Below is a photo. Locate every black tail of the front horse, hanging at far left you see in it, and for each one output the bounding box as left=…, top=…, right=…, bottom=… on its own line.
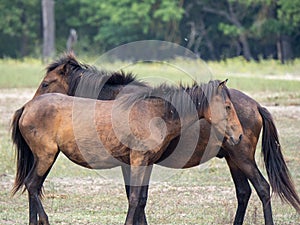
left=11, top=106, right=34, bottom=195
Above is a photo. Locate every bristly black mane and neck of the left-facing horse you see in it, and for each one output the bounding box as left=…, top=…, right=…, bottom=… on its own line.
left=47, top=54, right=146, bottom=99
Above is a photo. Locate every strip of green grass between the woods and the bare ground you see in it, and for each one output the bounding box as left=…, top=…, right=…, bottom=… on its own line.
left=0, top=58, right=300, bottom=92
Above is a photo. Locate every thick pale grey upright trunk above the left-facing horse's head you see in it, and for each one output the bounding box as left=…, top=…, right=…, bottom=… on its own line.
left=42, top=0, right=55, bottom=62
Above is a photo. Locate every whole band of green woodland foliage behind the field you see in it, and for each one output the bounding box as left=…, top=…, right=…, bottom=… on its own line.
left=0, top=0, right=300, bottom=59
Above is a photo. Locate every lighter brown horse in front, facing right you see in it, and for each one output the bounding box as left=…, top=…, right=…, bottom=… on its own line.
left=14, top=77, right=242, bottom=224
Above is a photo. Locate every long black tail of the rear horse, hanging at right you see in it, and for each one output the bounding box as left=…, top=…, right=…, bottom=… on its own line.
left=258, top=106, right=300, bottom=213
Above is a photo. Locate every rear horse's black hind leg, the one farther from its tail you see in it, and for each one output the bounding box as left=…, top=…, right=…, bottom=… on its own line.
left=226, top=157, right=251, bottom=225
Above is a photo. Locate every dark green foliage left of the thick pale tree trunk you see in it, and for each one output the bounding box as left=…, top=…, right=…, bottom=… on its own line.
left=0, top=0, right=40, bottom=57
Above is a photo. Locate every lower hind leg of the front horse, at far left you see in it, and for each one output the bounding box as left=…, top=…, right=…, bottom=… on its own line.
left=24, top=146, right=58, bottom=225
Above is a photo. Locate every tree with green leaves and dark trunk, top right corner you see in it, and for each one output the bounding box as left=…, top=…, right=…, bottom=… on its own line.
left=252, top=0, right=300, bottom=63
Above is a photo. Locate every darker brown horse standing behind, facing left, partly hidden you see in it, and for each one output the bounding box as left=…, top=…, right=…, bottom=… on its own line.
left=12, top=55, right=300, bottom=224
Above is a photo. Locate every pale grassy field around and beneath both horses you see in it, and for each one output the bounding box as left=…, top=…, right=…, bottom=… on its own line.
left=0, top=59, right=300, bottom=225
